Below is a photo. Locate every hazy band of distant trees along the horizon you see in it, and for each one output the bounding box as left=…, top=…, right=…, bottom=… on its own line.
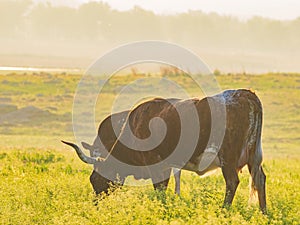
left=0, top=0, right=300, bottom=57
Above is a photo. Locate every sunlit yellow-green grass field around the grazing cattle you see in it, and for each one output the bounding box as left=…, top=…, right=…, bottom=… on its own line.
left=0, top=73, right=300, bottom=225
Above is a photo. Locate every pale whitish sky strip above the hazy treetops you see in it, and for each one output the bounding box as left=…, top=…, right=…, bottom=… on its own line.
left=43, top=0, right=300, bottom=19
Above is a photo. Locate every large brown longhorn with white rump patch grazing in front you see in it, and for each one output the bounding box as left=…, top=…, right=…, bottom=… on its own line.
left=64, top=89, right=266, bottom=212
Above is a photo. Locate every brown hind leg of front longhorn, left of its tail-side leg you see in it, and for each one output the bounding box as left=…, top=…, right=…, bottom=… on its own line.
left=222, top=167, right=240, bottom=207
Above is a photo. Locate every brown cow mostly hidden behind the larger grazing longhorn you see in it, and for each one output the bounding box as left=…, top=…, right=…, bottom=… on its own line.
left=81, top=108, right=181, bottom=195
